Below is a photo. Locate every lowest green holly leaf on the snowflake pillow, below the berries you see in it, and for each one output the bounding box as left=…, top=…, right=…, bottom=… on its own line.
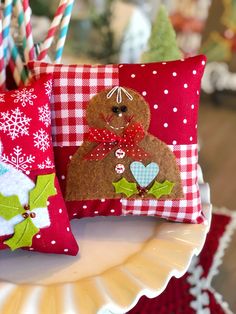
left=4, top=218, right=39, bottom=251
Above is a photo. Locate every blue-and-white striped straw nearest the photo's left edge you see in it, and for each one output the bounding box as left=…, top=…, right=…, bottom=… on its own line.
left=2, top=0, right=12, bottom=65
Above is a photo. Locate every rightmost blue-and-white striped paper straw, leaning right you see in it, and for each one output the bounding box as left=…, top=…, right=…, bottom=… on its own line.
left=55, top=0, right=74, bottom=63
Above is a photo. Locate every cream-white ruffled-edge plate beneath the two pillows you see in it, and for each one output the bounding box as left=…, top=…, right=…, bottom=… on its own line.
left=0, top=174, right=211, bottom=314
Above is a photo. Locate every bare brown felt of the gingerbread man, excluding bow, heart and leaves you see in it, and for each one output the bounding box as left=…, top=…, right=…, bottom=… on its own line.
left=66, top=89, right=183, bottom=201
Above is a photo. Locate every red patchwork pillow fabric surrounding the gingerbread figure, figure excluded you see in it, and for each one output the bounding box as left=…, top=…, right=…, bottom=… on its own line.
left=29, top=55, right=206, bottom=223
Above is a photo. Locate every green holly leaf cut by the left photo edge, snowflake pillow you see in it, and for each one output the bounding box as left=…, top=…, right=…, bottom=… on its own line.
left=0, top=194, right=24, bottom=220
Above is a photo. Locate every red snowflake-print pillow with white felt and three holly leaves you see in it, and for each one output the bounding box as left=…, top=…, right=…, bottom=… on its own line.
left=0, top=75, right=78, bottom=255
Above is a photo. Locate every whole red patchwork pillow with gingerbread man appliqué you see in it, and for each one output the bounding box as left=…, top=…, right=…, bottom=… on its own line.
left=29, top=56, right=206, bottom=223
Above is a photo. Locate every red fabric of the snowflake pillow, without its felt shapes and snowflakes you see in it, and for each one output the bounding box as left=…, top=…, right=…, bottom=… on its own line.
left=0, top=75, right=78, bottom=255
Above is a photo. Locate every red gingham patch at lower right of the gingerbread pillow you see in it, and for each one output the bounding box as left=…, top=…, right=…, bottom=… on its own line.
left=122, top=144, right=203, bottom=223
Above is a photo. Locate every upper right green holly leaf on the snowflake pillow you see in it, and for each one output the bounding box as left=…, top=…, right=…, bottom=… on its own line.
left=29, top=173, right=57, bottom=210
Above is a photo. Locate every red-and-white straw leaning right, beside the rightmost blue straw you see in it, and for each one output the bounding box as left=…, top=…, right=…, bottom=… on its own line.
left=38, top=0, right=68, bottom=60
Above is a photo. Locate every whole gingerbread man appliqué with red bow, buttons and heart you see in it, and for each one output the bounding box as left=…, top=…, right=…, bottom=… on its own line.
left=66, top=86, right=183, bottom=201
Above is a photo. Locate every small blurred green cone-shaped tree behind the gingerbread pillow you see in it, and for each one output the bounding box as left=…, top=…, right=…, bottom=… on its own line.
left=142, top=5, right=181, bottom=62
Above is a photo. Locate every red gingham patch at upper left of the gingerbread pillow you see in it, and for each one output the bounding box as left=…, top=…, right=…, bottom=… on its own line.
left=28, top=62, right=119, bottom=146
